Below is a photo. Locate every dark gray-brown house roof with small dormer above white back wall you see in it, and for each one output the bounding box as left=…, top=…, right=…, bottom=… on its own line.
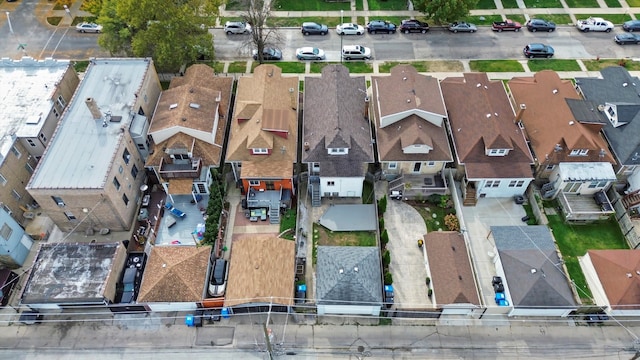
left=302, top=65, right=374, bottom=176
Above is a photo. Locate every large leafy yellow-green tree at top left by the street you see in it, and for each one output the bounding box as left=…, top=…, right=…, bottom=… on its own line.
left=97, top=0, right=221, bottom=71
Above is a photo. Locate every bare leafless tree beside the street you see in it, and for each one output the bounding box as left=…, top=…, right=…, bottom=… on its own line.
left=242, top=0, right=283, bottom=64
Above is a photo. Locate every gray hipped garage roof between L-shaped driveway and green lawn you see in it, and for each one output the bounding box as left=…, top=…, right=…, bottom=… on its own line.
left=491, top=225, right=576, bottom=307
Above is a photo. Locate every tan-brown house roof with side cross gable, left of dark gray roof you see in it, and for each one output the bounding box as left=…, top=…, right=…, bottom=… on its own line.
left=226, top=64, right=298, bottom=179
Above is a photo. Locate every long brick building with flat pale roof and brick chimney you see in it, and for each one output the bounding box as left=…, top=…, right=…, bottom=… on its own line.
left=27, top=58, right=161, bottom=234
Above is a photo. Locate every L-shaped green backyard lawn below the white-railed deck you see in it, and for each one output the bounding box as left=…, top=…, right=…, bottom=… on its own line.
left=547, top=215, right=628, bottom=301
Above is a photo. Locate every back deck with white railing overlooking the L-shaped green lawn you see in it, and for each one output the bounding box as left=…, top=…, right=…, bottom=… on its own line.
left=558, top=191, right=615, bottom=222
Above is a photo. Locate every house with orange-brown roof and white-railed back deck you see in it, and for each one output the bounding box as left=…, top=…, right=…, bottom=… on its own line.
left=509, top=70, right=616, bottom=221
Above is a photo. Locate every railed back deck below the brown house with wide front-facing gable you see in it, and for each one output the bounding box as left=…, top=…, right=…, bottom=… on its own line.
left=389, top=172, right=449, bottom=200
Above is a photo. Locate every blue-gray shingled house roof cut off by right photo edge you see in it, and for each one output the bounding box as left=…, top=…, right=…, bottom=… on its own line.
left=576, top=66, right=640, bottom=165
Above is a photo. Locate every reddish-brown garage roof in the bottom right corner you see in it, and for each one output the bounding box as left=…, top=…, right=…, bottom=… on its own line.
left=587, top=250, right=640, bottom=310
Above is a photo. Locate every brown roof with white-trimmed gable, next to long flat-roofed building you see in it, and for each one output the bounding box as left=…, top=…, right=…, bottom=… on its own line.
left=146, top=64, right=233, bottom=166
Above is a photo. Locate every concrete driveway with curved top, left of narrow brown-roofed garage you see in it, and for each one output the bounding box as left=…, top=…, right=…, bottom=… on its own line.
left=384, top=195, right=432, bottom=309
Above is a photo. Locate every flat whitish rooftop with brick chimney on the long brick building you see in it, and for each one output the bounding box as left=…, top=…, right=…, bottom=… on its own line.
left=27, top=59, right=151, bottom=189
